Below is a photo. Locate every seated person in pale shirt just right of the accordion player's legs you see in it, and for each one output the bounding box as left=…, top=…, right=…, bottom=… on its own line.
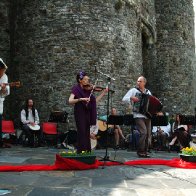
left=152, top=123, right=171, bottom=149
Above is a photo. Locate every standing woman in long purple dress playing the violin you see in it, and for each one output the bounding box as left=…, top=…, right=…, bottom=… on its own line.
left=69, top=71, right=97, bottom=153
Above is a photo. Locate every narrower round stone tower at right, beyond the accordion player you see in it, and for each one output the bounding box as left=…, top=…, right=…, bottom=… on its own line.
left=155, top=0, right=195, bottom=114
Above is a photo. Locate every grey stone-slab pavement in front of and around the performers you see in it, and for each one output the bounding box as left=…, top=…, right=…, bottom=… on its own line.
left=0, top=146, right=196, bottom=196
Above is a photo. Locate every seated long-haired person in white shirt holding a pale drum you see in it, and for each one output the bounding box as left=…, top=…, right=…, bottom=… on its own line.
left=21, top=99, right=41, bottom=146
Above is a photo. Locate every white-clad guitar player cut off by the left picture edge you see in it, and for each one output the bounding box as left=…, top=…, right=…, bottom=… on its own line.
left=0, top=58, right=10, bottom=147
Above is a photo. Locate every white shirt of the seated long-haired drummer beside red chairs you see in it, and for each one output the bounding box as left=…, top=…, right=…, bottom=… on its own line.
left=21, top=109, right=39, bottom=125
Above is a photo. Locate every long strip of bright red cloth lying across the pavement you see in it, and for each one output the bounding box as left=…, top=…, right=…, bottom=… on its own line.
left=0, top=155, right=196, bottom=172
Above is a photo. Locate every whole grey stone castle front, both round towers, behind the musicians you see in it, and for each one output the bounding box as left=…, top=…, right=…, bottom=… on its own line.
left=1, top=0, right=194, bottom=125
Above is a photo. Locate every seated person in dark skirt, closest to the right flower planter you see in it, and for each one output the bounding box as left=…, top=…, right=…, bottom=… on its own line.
left=169, top=114, right=191, bottom=149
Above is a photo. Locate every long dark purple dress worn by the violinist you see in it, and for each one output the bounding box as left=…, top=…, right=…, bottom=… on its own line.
left=71, top=84, right=97, bottom=153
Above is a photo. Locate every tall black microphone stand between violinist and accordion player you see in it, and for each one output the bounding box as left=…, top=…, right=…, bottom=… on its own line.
left=97, top=70, right=123, bottom=168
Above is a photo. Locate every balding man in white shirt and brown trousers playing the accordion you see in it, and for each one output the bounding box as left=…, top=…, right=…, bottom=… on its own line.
left=122, top=76, right=151, bottom=157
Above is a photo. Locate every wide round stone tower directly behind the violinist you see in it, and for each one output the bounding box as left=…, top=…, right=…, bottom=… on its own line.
left=9, top=0, right=154, bottom=125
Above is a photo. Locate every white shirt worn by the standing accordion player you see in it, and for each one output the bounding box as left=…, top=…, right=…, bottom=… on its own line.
left=122, top=88, right=151, bottom=118
